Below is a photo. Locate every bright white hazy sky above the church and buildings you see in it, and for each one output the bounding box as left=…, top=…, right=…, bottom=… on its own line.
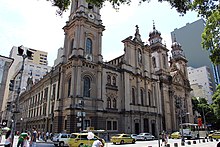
left=0, top=0, right=199, bottom=66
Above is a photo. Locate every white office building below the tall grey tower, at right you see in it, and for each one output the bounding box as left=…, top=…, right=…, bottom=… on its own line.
left=187, top=66, right=213, bottom=104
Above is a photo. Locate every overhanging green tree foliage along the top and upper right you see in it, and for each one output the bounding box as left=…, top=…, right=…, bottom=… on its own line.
left=47, top=0, right=220, bottom=64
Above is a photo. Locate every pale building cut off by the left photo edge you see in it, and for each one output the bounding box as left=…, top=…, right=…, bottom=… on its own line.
left=0, top=55, right=14, bottom=123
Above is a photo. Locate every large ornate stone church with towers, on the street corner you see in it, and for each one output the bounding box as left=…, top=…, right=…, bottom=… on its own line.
left=16, top=0, right=193, bottom=136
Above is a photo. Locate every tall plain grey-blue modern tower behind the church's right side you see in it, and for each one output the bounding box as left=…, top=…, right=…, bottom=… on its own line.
left=171, top=19, right=220, bottom=90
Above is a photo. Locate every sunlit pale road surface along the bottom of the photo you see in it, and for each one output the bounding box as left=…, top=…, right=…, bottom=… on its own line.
left=37, top=139, right=218, bottom=147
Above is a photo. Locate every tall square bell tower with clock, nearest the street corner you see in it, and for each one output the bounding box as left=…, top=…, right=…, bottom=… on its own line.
left=63, top=0, right=104, bottom=63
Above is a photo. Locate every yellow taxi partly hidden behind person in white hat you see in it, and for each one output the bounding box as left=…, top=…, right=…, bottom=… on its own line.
left=68, top=133, right=105, bottom=147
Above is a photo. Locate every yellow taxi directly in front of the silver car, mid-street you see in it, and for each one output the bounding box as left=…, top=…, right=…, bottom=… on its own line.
left=111, top=134, right=136, bottom=144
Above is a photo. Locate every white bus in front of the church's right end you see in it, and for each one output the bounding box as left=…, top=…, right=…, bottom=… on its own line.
left=180, top=123, right=207, bottom=139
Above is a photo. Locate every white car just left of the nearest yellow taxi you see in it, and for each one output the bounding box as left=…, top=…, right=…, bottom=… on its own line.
left=52, top=133, right=70, bottom=146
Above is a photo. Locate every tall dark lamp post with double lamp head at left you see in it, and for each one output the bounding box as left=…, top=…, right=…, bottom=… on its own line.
left=12, top=45, right=33, bottom=145
